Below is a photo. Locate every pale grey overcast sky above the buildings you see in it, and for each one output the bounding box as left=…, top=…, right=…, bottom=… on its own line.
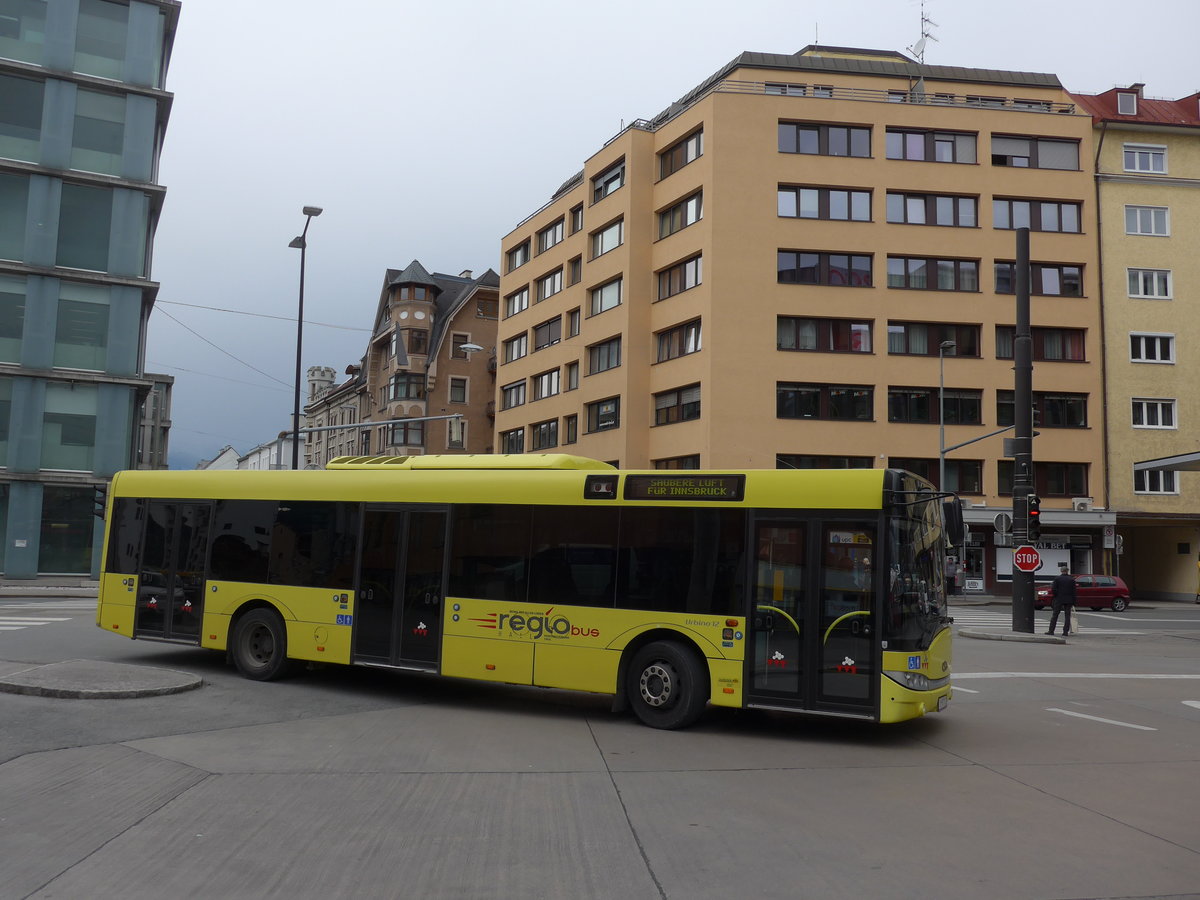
left=146, top=0, right=1200, bottom=468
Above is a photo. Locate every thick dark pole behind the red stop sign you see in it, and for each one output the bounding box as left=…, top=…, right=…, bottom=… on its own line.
left=1013, top=228, right=1034, bottom=635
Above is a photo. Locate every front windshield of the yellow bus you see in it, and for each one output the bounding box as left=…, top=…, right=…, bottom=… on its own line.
left=883, top=499, right=948, bottom=650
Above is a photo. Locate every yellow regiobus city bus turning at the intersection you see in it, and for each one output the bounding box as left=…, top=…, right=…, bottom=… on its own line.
left=96, top=454, right=961, bottom=728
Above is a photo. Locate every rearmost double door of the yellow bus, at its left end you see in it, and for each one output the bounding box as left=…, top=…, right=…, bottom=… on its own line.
left=133, top=500, right=212, bottom=643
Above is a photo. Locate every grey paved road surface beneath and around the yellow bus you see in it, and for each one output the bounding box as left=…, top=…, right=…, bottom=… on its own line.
left=0, top=599, right=1200, bottom=900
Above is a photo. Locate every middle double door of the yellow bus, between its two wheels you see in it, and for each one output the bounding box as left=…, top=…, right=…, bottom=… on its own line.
left=354, top=508, right=448, bottom=670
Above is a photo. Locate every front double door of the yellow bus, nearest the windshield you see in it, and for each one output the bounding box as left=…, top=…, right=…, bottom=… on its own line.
left=748, top=518, right=877, bottom=714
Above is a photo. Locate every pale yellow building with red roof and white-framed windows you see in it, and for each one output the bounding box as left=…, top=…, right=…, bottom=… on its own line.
left=1075, top=84, right=1200, bottom=599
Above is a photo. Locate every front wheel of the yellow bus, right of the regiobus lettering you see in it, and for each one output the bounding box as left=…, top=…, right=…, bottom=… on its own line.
left=625, top=641, right=708, bottom=728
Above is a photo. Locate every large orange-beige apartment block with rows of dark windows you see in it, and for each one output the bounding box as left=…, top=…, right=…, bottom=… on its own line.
left=496, top=47, right=1114, bottom=592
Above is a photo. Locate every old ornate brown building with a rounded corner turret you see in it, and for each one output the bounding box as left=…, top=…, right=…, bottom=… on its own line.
left=305, top=259, right=500, bottom=467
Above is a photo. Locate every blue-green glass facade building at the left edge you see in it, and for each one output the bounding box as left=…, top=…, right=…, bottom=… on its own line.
left=0, top=0, right=180, bottom=580
